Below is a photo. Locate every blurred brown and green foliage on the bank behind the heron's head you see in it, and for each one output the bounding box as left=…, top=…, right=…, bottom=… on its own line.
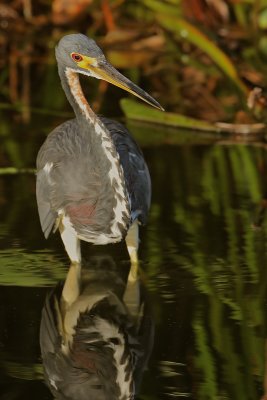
left=0, top=0, right=267, bottom=134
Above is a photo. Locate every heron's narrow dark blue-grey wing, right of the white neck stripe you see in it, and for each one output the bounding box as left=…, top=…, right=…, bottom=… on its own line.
left=101, top=117, right=151, bottom=224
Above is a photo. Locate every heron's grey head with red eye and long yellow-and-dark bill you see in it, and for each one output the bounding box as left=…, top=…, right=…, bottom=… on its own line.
left=56, top=34, right=163, bottom=110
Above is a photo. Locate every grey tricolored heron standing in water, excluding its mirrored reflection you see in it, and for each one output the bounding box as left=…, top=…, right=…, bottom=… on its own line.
left=36, top=34, right=162, bottom=264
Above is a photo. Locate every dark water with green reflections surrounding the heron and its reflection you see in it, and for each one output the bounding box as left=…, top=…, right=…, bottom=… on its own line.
left=0, top=116, right=267, bottom=400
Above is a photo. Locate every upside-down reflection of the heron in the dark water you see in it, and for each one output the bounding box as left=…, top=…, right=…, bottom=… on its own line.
left=40, top=256, right=154, bottom=400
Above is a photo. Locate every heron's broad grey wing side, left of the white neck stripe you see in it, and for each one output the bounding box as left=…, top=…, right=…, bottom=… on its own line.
left=36, top=119, right=120, bottom=242
